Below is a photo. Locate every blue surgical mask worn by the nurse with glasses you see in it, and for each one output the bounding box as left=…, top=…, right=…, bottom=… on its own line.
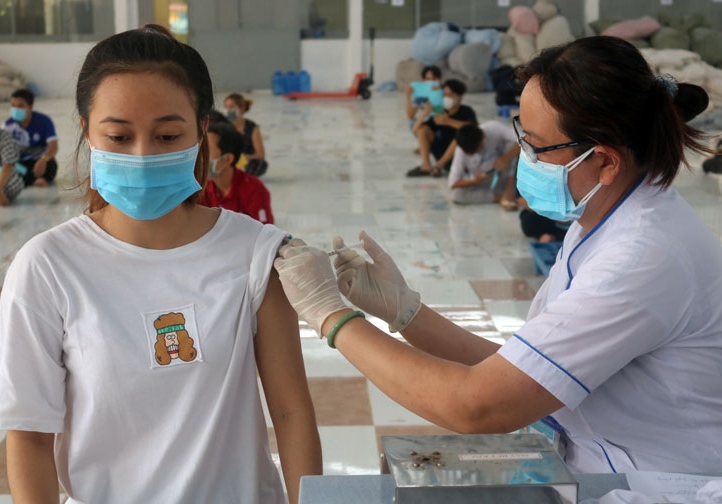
left=516, top=147, right=602, bottom=221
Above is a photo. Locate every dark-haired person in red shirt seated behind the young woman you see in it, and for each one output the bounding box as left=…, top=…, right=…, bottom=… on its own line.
left=199, top=122, right=273, bottom=224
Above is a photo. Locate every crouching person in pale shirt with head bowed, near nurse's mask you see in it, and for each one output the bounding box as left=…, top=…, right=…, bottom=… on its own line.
left=449, top=121, right=519, bottom=210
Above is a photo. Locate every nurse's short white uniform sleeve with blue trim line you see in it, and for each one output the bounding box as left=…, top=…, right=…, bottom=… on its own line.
left=499, top=236, right=695, bottom=409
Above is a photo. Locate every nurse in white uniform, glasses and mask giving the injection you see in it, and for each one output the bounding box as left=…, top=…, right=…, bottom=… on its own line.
left=276, top=37, right=722, bottom=473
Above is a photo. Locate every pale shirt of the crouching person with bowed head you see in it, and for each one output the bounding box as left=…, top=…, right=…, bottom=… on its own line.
left=448, top=121, right=516, bottom=187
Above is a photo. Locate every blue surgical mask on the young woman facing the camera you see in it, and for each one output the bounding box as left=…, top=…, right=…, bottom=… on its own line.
left=90, top=144, right=201, bottom=220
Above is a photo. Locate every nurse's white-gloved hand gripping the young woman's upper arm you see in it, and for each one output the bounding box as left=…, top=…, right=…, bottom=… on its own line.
left=273, top=238, right=348, bottom=337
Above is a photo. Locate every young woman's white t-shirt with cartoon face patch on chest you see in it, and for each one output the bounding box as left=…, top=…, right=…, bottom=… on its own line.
left=0, top=211, right=285, bottom=504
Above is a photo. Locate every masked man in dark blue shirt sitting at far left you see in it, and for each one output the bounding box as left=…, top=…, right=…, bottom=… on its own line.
left=3, top=89, right=58, bottom=187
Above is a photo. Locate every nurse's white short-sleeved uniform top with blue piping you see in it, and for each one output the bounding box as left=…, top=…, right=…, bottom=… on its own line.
left=499, top=182, right=722, bottom=473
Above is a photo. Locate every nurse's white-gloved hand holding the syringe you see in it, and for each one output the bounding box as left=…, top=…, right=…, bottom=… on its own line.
left=333, top=231, right=421, bottom=332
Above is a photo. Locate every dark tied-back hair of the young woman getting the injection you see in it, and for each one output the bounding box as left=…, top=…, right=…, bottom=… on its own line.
left=75, top=24, right=214, bottom=212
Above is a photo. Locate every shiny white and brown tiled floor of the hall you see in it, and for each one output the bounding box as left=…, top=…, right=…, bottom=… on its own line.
left=0, top=92, right=722, bottom=504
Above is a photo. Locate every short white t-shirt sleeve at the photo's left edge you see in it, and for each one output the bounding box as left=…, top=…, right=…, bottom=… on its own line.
left=0, top=238, right=66, bottom=433
